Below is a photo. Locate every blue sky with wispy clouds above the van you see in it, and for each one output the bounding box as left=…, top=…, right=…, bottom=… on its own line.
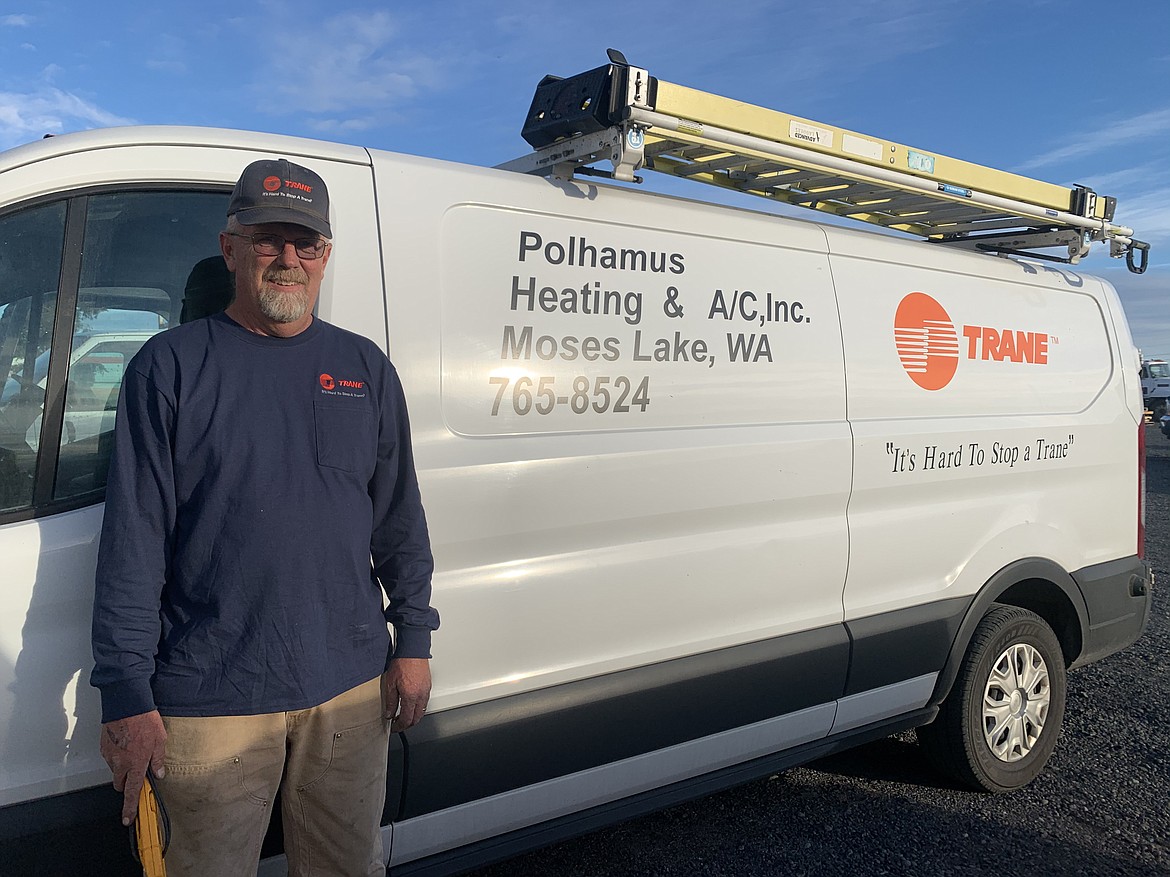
left=0, top=0, right=1170, bottom=358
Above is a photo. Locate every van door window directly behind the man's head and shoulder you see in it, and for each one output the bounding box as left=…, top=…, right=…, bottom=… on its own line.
left=53, top=192, right=227, bottom=499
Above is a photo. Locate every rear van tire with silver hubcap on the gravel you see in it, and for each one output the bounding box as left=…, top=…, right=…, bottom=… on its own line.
left=918, top=605, right=1067, bottom=792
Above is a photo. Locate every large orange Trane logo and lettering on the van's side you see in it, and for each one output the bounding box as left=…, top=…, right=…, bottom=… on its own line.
left=894, top=292, right=1057, bottom=389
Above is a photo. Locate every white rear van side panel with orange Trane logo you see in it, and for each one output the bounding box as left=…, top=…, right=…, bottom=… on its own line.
left=830, top=230, right=1136, bottom=619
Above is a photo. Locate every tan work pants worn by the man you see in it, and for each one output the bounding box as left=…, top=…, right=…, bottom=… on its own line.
left=159, top=679, right=390, bottom=877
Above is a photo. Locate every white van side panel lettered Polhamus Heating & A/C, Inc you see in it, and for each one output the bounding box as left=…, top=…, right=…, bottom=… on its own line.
left=373, top=152, right=849, bottom=710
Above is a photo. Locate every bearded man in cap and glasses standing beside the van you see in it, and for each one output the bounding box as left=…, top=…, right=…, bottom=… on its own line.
left=92, top=159, right=439, bottom=877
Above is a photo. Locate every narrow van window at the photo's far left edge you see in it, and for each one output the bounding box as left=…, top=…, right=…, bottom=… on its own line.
left=0, top=201, right=66, bottom=511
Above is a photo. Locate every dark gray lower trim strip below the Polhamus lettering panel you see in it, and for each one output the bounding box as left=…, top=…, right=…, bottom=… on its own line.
left=394, top=624, right=847, bottom=822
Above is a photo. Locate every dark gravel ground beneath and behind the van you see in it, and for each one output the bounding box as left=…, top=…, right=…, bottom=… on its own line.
left=463, top=427, right=1170, bottom=877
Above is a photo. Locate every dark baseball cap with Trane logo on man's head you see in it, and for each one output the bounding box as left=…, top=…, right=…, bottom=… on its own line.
left=227, top=158, right=333, bottom=237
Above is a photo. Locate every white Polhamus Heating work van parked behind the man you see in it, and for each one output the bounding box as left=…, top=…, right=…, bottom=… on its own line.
left=0, top=58, right=1152, bottom=873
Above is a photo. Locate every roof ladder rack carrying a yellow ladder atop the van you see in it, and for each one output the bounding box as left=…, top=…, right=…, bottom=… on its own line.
left=498, top=49, right=1149, bottom=274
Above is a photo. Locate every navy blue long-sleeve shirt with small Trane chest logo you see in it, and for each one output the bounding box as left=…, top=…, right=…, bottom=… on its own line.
left=91, top=315, right=439, bottom=721
